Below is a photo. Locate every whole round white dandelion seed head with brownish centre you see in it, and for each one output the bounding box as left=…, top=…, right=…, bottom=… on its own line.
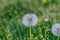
left=22, top=14, right=38, bottom=26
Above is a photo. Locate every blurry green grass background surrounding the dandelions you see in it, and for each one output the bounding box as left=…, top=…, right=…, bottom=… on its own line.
left=0, top=0, right=60, bottom=40
